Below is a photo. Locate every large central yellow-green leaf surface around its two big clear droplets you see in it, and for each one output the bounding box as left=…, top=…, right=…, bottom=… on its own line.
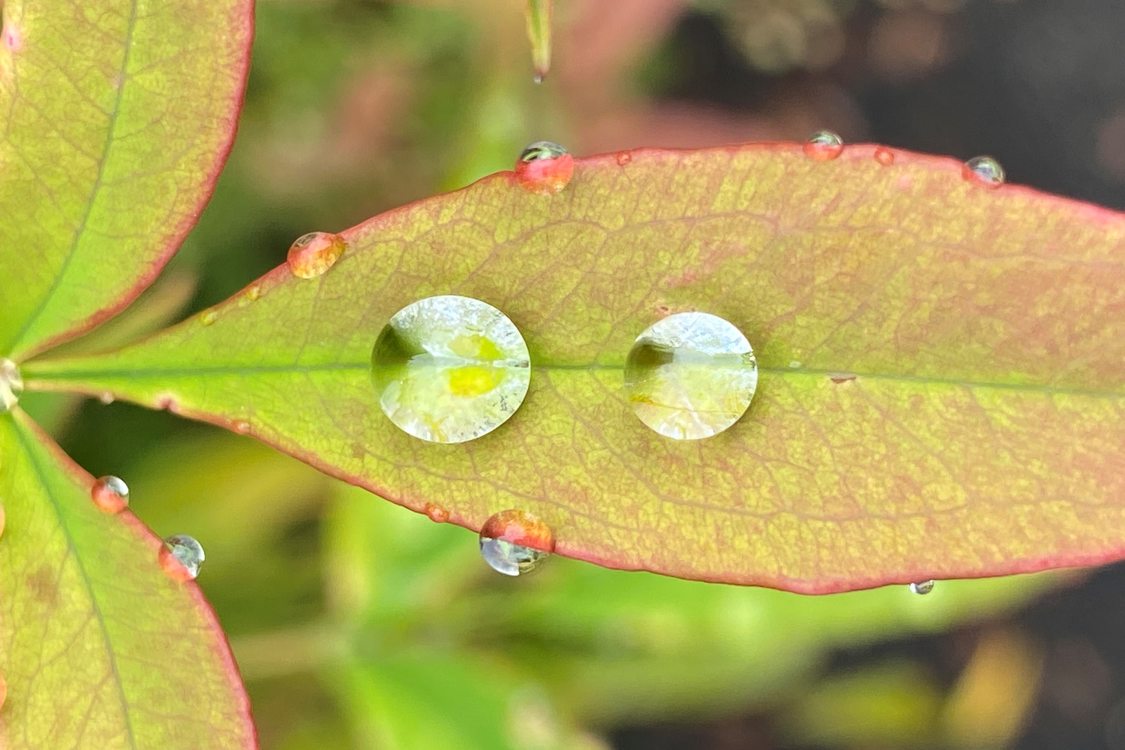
left=24, top=144, right=1125, bottom=593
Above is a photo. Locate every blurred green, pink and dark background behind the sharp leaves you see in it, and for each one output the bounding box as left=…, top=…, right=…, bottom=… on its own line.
left=25, top=0, right=1125, bottom=750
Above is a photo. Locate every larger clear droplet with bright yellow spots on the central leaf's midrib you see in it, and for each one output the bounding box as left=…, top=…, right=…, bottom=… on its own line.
left=371, top=295, right=531, bottom=443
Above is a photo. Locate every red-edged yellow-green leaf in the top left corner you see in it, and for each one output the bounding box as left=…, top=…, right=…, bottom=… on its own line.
left=0, top=0, right=253, bottom=359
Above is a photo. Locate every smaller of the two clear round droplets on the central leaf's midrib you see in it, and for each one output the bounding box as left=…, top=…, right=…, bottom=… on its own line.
left=626, top=313, right=758, bottom=440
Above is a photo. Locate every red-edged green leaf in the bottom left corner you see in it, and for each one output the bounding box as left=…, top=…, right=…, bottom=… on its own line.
left=0, top=412, right=255, bottom=750
